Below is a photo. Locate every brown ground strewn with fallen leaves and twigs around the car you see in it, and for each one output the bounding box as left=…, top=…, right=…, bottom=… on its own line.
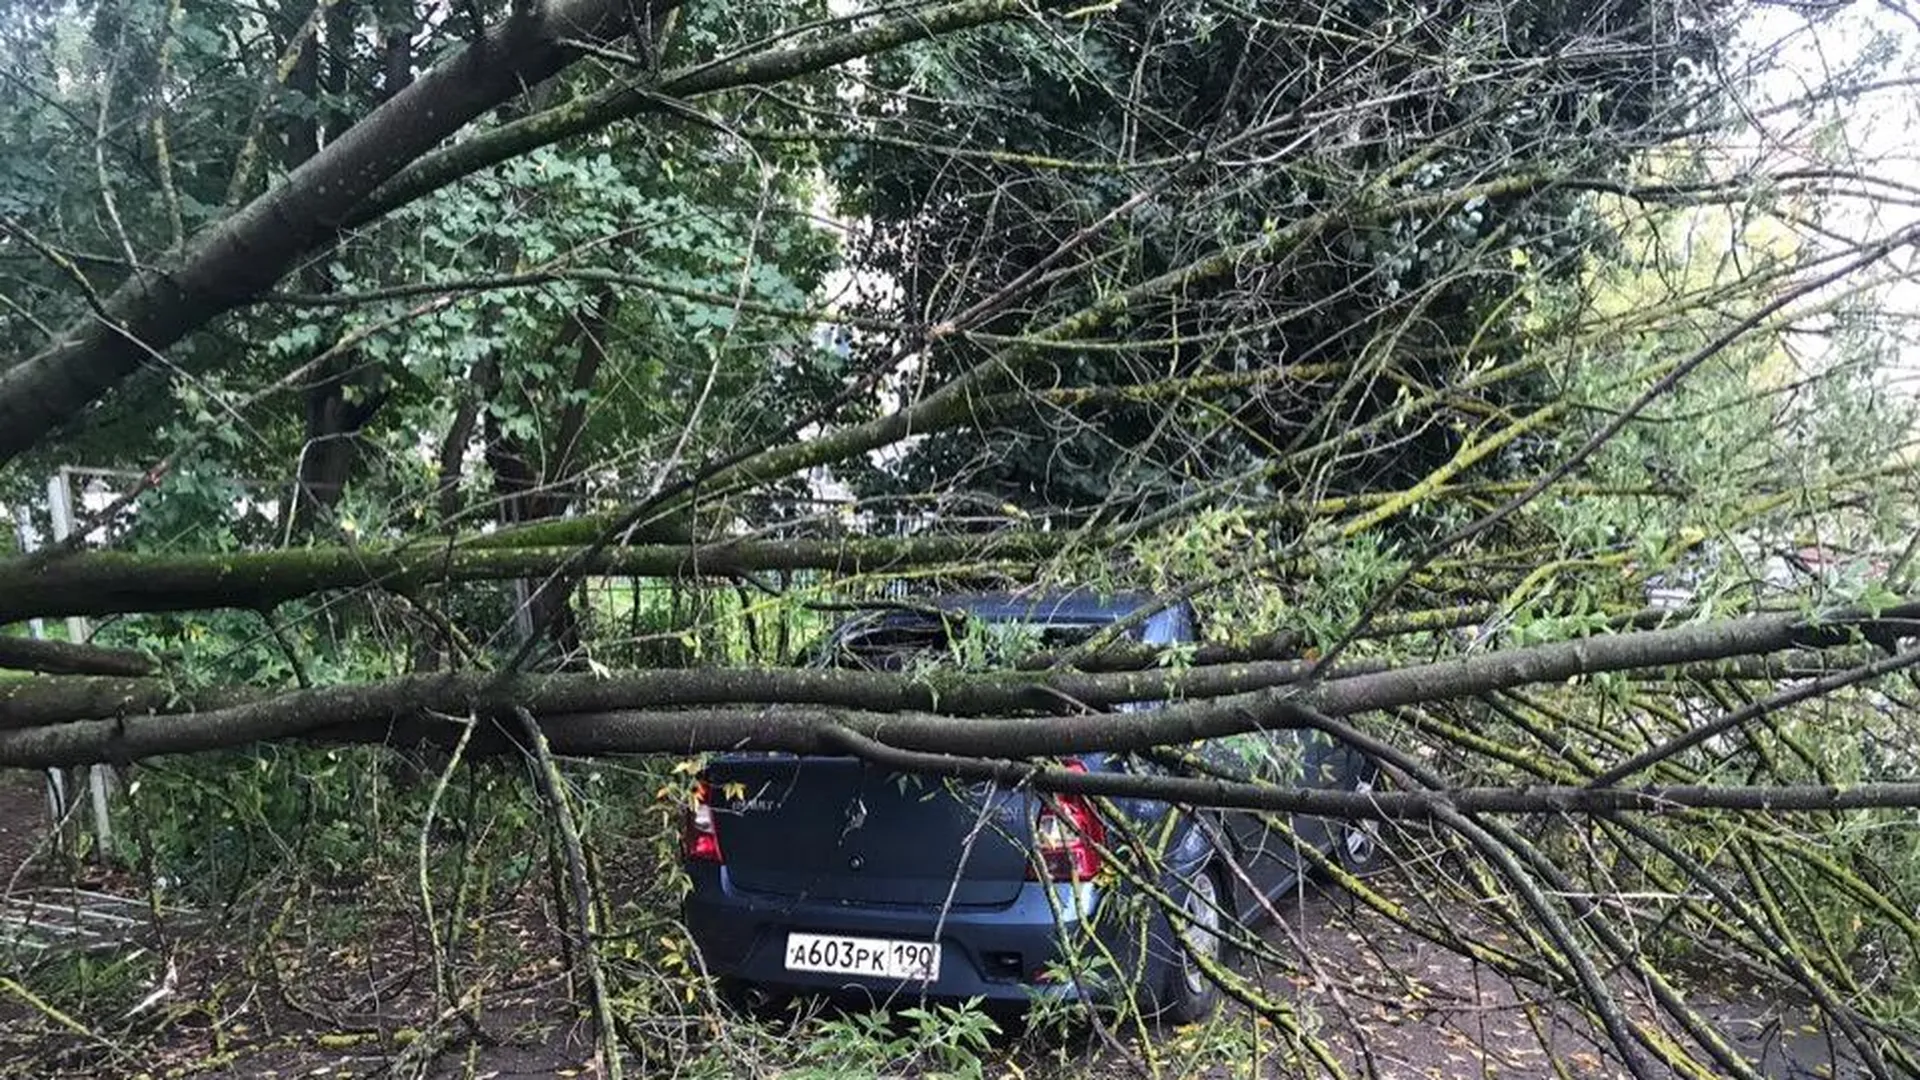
left=0, top=773, right=1847, bottom=1080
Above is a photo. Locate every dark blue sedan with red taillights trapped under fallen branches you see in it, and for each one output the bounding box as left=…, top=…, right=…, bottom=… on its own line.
left=685, top=592, right=1375, bottom=1022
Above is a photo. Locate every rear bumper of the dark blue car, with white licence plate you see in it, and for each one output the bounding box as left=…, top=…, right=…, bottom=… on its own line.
left=685, top=865, right=1127, bottom=1003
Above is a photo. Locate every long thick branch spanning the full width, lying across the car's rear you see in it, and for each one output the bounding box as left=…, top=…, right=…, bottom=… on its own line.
left=0, top=605, right=1920, bottom=767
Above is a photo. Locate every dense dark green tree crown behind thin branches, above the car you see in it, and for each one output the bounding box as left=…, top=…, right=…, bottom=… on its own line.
left=831, top=0, right=1716, bottom=519
